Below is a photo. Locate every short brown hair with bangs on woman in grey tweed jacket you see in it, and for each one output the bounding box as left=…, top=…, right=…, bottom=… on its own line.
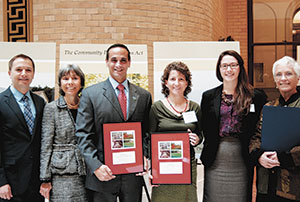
left=58, top=64, right=85, bottom=96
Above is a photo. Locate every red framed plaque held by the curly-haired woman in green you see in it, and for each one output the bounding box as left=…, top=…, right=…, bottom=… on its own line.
left=151, top=132, right=192, bottom=184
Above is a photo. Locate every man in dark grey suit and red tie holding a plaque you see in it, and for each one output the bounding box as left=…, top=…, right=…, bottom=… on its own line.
left=76, top=44, right=152, bottom=202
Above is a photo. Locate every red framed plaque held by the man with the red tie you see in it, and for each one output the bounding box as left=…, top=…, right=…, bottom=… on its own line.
left=103, top=122, right=144, bottom=175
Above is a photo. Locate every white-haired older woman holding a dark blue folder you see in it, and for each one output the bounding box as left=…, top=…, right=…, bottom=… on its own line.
left=249, top=56, right=300, bottom=202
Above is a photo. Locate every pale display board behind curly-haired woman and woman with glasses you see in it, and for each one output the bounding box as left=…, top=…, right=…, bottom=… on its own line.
left=153, top=42, right=240, bottom=103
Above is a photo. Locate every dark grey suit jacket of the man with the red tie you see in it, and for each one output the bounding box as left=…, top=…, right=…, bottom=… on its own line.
left=76, top=79, right=152, bottom=191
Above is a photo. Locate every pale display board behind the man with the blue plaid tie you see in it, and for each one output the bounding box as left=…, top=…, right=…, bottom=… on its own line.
left=0, top=42, right=56, bottom=91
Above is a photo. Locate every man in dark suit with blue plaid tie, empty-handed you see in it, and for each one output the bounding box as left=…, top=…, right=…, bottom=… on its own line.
left=0, top=54, right=45, bottom=202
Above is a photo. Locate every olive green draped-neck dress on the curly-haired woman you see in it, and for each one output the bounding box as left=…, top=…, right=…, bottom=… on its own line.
left=149, top=101, right=202, bottom=202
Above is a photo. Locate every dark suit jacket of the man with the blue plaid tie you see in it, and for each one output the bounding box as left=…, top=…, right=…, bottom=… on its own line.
left=0, top=88, right=45, bottom=195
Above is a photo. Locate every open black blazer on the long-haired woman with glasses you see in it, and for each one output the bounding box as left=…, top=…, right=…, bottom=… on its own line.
left=201, top=85, right=266, bottom=168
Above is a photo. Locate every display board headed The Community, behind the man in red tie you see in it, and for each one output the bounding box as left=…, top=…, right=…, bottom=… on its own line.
left=60, top=44, right=148, bottom=89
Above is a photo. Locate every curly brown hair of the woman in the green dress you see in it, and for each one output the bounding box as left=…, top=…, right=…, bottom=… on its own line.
left=161, top=62, right=192, bottom=97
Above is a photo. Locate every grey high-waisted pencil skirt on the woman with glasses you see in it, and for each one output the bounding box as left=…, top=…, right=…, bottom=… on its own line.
left=203, top=137, right=248, bottom=202
